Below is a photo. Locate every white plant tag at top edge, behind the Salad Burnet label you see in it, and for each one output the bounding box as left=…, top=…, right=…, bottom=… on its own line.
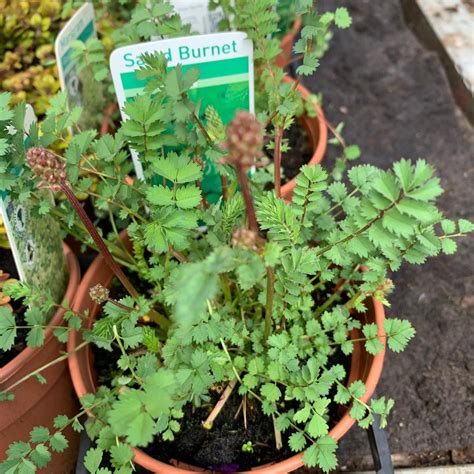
left=170, top=0, right=224, bottom=35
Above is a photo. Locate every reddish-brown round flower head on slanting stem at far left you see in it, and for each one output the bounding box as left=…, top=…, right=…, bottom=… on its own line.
left=26, top=147, right=66, bottom=191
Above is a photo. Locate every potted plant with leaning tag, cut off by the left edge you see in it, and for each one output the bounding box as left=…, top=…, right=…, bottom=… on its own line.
left=0, top=102, right=80, bottom=472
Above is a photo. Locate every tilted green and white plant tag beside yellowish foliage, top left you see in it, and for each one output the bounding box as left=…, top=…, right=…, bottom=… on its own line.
left=54, top=3, right=97, bottom=107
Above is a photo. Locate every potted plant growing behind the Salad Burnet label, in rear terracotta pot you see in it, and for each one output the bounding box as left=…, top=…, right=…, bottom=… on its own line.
left=68, top=0, right=359, bottom=194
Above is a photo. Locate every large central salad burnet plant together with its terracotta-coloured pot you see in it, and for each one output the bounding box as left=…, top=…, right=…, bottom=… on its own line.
left=0, top=7, right=473, bottom=473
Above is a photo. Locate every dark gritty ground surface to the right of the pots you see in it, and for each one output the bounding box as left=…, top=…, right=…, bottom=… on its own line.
left=301, top=0, right=474, bottom=472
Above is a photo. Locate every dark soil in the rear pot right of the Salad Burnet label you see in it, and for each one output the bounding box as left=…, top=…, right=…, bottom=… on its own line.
left=266, top=120, right=313, bottom=184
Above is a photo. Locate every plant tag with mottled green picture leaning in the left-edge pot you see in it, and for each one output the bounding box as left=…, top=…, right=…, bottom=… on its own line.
left=0, top=105, right=68, bottom=310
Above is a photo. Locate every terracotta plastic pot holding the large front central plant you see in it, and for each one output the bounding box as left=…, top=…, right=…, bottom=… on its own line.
left=68, top=241, right=385, bottom=474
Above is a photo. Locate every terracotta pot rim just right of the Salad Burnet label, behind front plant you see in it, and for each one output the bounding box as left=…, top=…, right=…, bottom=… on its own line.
left=281, top=76, right=328, bottom=201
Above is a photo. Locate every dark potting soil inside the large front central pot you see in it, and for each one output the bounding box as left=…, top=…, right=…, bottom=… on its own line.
left=93, top=347, right=350, bottom=473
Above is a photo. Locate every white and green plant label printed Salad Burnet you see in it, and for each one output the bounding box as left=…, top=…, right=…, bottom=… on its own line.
left=110, top=32, right=254, bottom=203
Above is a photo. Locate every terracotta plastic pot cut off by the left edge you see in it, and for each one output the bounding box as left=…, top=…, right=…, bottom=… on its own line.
left=0, top=245, right=80, bottom=474
